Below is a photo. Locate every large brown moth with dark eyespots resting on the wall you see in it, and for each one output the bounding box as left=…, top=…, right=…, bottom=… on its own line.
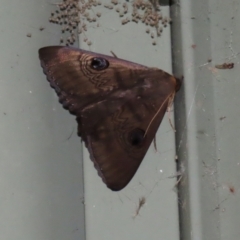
left=39, top=46, right=181, bottom=191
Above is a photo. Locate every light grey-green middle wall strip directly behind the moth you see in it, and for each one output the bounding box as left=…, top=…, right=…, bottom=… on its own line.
left=80, top=1, right=179, bottom=240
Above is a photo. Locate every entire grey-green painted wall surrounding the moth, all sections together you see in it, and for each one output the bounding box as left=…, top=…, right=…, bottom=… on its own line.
left=0, top=0, right=240, bottom=240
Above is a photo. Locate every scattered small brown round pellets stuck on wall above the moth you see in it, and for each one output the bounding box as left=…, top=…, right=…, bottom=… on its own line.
left=49, top=0, right=171, bottom=46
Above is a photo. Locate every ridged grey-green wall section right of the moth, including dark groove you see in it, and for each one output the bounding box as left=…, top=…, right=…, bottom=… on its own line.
left=172, top=0, right=240, bottom=240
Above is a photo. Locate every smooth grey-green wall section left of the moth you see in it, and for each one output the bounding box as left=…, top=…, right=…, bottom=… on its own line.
left=0, top=0, right=84, bottom=240
